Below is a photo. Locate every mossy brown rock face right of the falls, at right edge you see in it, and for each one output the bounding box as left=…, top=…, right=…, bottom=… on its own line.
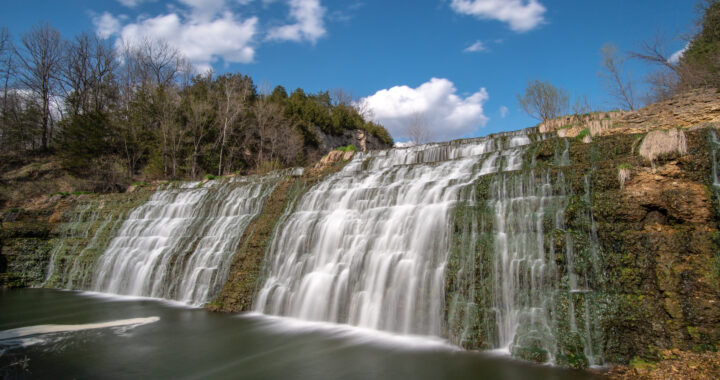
left=593, top=130, right=720, bottom=363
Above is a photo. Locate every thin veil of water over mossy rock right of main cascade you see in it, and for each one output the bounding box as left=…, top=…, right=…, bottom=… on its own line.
left=489, top=171, right=560, bottom=347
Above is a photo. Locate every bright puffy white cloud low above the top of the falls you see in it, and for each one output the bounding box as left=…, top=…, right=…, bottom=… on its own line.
left=361, top=78, right=488, bottom=140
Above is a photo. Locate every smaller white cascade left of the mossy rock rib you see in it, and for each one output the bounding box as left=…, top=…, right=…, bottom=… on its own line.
left=92, top=175, right=280, bottom=305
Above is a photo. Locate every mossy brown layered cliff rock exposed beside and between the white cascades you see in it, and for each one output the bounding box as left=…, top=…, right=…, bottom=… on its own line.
left=0, top=91, right=720, bottom=367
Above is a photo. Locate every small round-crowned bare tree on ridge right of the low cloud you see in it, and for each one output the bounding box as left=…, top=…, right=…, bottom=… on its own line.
left=517, top=80, right=570, bottom=121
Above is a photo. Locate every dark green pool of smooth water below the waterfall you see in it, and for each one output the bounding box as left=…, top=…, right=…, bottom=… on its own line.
left=0, top=289, right=596, bottom=380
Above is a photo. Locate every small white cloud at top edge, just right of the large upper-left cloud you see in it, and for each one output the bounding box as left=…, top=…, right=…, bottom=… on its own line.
left=268, top=0, right=326, bottom=43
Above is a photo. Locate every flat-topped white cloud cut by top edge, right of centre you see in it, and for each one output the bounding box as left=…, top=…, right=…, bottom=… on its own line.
left=450, top=0, right=546, bottom=32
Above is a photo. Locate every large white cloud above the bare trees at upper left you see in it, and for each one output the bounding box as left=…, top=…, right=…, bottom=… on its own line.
left=120, top=12, right=258, bottom=69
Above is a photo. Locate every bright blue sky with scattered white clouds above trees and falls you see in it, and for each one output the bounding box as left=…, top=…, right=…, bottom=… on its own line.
left=0, top=0, right=696, bottom=140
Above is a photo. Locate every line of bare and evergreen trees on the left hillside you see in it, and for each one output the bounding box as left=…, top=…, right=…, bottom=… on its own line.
left=0, top=24, right=392, bottom=190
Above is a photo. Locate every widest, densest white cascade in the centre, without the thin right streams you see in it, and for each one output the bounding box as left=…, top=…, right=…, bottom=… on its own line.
left=254, top=131, right=542, bottom=336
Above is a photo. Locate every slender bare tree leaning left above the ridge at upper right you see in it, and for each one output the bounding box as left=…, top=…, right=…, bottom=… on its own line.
left=600, top=43, right=637, bottom=111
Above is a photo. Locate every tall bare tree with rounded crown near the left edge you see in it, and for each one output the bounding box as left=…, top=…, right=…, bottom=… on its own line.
left=18, top=24, right=64, bottom=149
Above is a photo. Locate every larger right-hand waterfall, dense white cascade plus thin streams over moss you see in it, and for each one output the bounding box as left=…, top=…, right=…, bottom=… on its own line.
left=254, top=129, right=602, bottom=366
